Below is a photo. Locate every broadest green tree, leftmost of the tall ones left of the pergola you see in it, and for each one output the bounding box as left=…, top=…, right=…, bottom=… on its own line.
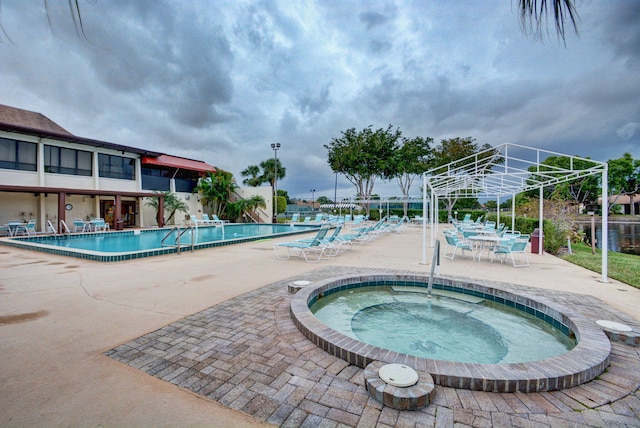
left=324, top=125, right=402, bottom=214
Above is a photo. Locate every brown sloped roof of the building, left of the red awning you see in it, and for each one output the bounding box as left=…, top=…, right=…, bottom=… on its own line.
left=0, top=104, right=161, bottom=156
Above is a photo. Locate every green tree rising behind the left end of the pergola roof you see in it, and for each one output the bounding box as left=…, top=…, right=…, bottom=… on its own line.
left=432, top=137, right=495, bottom=216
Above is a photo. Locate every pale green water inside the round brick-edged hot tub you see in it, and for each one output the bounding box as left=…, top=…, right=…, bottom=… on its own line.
left=310, top=287, right=576, bottom=364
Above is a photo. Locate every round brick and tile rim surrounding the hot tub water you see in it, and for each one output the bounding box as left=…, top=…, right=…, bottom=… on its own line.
left=290, top=272, right=611, bottom=392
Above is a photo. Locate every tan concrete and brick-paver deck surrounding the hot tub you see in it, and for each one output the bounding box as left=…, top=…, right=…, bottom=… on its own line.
left=0, top=227, right=640, bottom=427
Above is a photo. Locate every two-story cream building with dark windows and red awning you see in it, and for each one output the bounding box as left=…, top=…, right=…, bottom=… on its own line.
left=0, top=105, right=215, bottom=231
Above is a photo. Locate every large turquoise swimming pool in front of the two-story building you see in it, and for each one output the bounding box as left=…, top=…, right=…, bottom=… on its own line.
left=0, top=223, right=318, bottom=262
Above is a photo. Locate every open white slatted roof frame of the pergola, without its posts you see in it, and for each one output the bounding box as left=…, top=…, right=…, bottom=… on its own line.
left=424, top=144, right=607, bottom=198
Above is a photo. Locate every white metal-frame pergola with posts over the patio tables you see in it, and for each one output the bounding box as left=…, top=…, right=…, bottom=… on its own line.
left=422, top=144, right=609, bottom=282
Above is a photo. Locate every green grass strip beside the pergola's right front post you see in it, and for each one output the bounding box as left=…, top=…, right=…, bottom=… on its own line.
left=562, top=243, right=640, bottom=288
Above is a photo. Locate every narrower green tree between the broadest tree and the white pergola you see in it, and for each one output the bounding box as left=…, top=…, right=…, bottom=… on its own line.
left=390, top=137, right=433, bottom=215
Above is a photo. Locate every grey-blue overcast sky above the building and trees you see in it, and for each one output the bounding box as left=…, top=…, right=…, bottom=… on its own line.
left=0, top=0, right=640, bottom=199
